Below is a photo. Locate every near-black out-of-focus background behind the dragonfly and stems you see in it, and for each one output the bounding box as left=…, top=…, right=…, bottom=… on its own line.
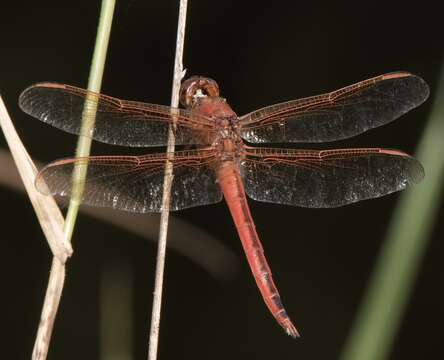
left=0, top=0, right=444, bottom=360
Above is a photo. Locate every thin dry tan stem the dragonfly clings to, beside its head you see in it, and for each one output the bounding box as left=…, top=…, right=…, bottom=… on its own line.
left=148, top=0, right=188, bottom=360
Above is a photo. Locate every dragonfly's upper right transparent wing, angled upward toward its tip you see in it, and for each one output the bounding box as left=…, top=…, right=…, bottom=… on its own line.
left=240, top=72, right=429, bottom=143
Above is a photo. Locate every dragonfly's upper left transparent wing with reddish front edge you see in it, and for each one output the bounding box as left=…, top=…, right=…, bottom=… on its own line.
left=19, top=83, right=214, bottom=147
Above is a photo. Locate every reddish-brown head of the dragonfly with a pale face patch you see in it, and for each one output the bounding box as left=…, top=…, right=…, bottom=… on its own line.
left=180, top=76, right=219, bottom=108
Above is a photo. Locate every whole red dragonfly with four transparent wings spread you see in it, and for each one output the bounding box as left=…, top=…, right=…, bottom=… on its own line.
left=19, top=72, right=429, bottom=337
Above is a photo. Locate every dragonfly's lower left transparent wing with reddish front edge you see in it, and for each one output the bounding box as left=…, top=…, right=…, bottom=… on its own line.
left=36, top=149, right=222, bottom=213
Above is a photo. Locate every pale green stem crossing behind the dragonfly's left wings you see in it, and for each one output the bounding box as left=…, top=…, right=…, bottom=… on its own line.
left=64, top=0, right=115, bottom=241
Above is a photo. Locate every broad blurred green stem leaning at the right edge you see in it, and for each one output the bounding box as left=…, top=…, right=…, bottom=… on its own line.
left=341, top=64, right=444, bottom=360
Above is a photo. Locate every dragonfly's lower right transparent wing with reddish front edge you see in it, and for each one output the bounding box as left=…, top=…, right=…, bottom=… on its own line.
left=242, top=148, right=424, bottom=208
